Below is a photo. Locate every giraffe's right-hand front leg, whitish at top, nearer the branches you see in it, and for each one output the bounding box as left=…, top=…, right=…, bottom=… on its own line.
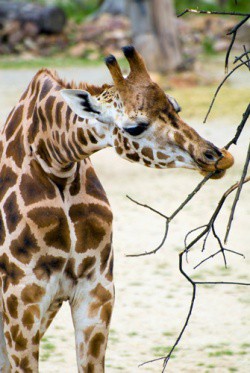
left=71, top=282, right=114, bottom=373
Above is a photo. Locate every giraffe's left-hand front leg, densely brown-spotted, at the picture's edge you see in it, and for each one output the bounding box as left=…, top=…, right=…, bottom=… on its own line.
left=2, top=283, right=45, bottom=373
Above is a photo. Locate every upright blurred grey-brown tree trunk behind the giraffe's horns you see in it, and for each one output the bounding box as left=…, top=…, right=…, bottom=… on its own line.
left=127, top=0, right=182, bottom=72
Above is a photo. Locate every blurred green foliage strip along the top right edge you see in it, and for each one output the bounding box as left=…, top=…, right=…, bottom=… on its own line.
left=174, top=0, right=249, bottom=13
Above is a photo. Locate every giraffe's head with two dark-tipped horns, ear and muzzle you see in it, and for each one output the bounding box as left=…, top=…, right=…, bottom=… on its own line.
left=62, top=46, right=233, bottom=178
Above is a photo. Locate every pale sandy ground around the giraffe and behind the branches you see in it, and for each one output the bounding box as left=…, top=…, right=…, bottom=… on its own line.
left=0, top=68, right=250, bottom=373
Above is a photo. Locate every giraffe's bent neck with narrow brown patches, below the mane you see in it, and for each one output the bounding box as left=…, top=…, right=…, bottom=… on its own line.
left=21, top=74, right=114, bottom=178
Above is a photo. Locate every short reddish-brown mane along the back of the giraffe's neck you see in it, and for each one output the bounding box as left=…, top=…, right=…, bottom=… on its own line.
left=36, top=68, right=112, bottom=96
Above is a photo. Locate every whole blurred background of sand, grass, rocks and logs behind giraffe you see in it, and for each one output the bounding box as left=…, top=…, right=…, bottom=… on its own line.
left=0, top=0, right=250, bottom=373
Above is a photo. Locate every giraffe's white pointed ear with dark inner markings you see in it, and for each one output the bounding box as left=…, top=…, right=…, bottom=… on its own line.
left=60, top=89, right=112, bottom=122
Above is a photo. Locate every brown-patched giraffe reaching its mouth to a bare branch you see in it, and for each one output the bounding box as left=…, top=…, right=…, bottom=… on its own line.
left=0, top=46, right=233, bottom=373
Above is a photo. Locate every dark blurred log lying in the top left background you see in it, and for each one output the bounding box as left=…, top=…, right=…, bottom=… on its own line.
left=0, top=1, right=66, bottom=34
